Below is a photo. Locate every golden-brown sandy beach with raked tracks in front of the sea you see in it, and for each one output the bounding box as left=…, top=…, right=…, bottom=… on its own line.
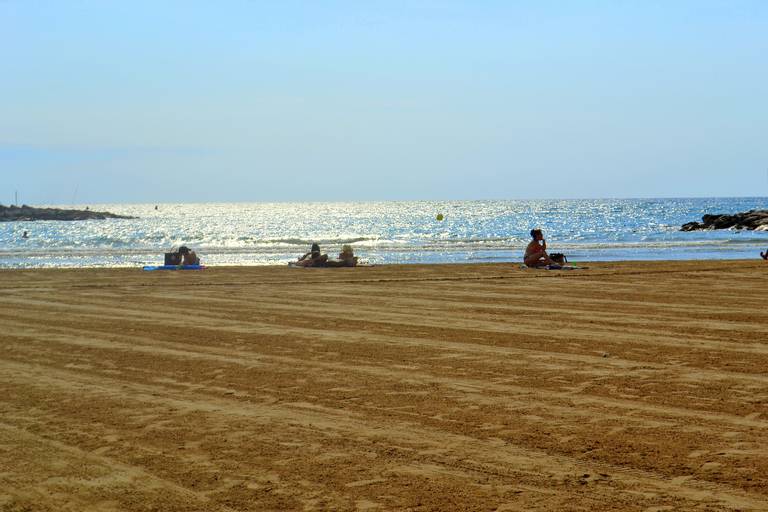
left=0, top=261, right=768, bottom=512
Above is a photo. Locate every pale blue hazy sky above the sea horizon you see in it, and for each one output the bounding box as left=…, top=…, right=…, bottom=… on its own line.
left=0, top=0, right=768, bottom=204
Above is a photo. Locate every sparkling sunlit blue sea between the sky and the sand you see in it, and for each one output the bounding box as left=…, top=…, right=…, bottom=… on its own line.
left=0, top=197, right=768, bottom=268
